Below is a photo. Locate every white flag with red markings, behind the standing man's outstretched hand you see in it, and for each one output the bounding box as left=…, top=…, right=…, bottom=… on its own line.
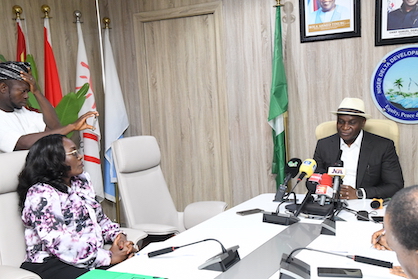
left=76, top=22, right=104, bottom=201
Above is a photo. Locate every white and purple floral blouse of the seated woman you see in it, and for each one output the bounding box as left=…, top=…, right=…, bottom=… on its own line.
left=22, top=173, right=122, bottom=268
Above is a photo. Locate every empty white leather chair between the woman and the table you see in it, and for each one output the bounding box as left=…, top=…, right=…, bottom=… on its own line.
left=112, top=136, right=227, bottom=236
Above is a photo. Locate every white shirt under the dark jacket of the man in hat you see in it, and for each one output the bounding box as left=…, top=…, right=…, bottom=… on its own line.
left=340, top=130, right=363, bottom=189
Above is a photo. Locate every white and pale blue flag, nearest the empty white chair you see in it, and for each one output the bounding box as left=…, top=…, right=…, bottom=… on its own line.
left=103, top=28, right=129, bottom=202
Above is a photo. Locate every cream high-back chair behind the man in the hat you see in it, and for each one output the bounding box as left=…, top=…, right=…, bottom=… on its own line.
left=315, top=119, right=399, bottom=153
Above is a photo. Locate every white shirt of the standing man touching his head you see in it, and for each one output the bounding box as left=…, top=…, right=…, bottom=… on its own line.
left=0, top=107, right=46, bottom=153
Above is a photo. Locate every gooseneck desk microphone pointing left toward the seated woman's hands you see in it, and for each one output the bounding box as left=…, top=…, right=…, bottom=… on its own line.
left=148, top=238, right=241, bottom=271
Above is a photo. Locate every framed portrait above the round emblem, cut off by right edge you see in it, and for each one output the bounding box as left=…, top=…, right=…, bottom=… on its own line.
left=375, top=0, right=418, bottom=46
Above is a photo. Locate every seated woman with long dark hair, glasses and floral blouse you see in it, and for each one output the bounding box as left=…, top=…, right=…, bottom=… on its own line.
left=18, top=135, right=136, bottom=279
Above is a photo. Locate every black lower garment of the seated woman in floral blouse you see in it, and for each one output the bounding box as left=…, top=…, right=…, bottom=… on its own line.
left=20, top=258, right=110, bottom=279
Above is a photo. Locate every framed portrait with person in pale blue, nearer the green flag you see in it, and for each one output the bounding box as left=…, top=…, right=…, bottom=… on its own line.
left=299, top=0, right=361, bottom=43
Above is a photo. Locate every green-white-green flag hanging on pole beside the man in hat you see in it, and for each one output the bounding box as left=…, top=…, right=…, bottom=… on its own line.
left=268, top=6, right=288, bottom=190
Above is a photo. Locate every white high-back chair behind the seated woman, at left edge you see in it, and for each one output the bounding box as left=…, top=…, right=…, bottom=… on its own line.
left=0, top=151, right=41, bottom=279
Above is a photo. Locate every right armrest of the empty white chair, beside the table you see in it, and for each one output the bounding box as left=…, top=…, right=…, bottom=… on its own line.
left=183, top=201, right=227, bottom=229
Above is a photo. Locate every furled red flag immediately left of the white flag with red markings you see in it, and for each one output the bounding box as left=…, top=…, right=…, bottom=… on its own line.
left=44, top=17, right=62, bottom=107
